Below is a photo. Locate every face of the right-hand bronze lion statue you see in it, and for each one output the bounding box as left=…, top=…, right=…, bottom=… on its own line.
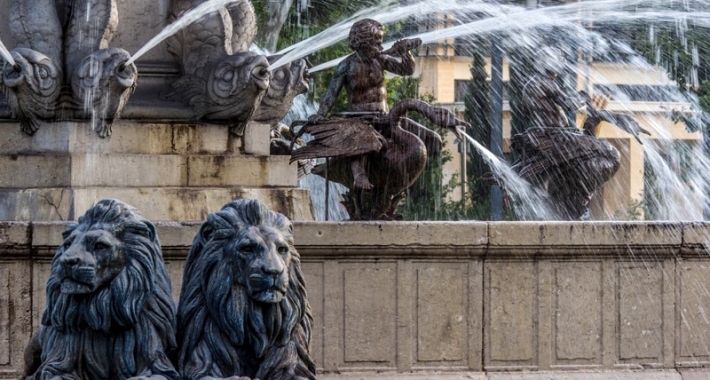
left=231, top=225, right=291, bottom=303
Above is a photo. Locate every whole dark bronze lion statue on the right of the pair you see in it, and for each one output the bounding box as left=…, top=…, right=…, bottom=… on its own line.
left=177, top=199, right=315, bottom=380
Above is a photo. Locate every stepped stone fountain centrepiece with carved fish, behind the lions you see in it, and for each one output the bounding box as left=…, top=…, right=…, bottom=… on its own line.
left=0, top=0, right=312, bottom=220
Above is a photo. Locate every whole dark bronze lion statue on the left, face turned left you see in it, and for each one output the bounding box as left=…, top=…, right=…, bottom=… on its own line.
left=25, top=199, right=179, bottom=380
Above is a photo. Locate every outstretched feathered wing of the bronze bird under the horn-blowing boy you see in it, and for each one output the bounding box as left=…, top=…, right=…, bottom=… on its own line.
left=291, top=119, right=384, bottom=162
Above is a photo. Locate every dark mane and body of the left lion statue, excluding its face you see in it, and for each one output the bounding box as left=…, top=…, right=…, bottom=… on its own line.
left=29, top=199, right=178, bottom=380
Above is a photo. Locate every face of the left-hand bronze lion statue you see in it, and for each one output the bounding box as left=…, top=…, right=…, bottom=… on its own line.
left=57, top=229, right=126, bottom=294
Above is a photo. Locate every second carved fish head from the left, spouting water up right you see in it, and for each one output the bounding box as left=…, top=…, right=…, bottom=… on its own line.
left=71, top=48, right=138, bottom=137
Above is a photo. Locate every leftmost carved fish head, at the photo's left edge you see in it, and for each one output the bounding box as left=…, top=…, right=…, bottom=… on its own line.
left=0, top=48, right=62, bottom=135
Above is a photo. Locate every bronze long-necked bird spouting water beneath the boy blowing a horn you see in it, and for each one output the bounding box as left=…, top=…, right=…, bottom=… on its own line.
left=291, top=99, right=469, bottom=220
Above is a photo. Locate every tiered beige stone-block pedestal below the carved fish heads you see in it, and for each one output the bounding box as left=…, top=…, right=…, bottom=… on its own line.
left=0, top=120, right=313, bottom=221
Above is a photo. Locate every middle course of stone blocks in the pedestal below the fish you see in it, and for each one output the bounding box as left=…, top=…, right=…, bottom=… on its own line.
left=0, top=153, right=298, bottom=189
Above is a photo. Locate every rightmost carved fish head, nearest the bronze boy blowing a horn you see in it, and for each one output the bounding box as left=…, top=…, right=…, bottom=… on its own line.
left=252, top=56, right=310, bottom=128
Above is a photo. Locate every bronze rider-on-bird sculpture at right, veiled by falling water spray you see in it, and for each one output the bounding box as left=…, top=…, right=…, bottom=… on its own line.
left=511, top=48, right=648, bottom=220
